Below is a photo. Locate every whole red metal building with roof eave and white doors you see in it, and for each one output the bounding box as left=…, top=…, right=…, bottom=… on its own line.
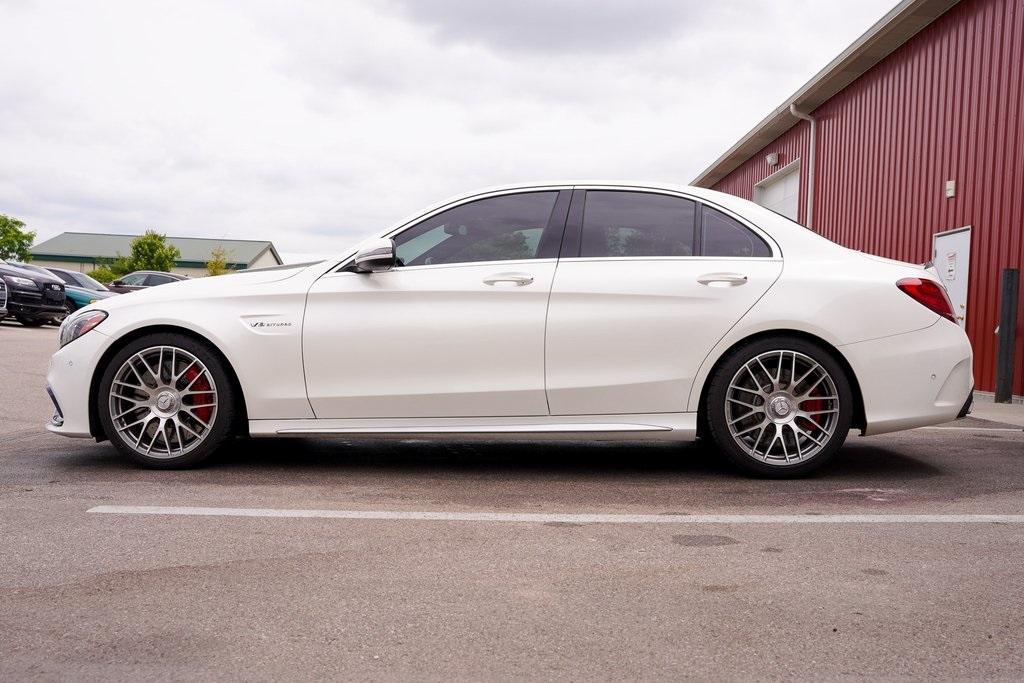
left=692, top=0, right=1024, bottom=396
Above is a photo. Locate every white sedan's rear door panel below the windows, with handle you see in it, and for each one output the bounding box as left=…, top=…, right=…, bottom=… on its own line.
left=547, top=258, right=782, bottom=415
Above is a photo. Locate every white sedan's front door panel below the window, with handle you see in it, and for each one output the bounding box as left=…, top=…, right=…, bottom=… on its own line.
left=302, top=259, right=555, bottom=418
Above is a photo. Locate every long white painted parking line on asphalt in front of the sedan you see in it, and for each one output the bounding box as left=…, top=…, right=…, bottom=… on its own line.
left=88, top=505, right=1024, bottom=524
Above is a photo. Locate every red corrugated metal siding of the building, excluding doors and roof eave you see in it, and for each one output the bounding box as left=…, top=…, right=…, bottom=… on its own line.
left=715, top=0, right=1024, bottom=394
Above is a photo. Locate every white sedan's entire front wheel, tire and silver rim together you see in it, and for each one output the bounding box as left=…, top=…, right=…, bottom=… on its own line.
left=96, top=334, right=234, bottom=469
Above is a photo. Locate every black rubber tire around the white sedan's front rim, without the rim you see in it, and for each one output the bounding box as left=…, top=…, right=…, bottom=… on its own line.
left=95, top=333, right=236, bottom=469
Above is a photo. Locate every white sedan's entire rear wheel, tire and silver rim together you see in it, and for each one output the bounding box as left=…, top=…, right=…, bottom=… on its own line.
left=706, top=337, right=853, bottom=477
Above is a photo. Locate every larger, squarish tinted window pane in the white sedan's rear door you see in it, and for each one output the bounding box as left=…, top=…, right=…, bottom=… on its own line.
left=580, top=190, right=695, bottom=257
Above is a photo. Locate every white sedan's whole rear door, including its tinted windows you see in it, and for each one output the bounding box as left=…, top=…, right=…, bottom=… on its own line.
left=546, top=189, right=782, bottom=415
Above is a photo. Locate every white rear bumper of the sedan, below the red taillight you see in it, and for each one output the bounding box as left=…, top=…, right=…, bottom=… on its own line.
left=840, top=318, right=974, bottom=435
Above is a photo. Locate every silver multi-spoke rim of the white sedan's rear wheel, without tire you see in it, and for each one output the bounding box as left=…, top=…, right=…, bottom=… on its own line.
left=725, top=349, right=840, bottom=466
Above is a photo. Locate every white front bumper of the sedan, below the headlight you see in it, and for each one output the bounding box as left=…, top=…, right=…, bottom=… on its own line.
left=46, top=330, right=112, bottom=437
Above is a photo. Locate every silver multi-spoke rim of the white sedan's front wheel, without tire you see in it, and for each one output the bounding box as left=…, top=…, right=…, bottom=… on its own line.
left=109, top=346, right=218, bottom=459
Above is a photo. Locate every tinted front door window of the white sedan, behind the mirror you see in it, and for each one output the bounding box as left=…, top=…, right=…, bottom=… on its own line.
left=394, top=191, right=558, bottom=265
